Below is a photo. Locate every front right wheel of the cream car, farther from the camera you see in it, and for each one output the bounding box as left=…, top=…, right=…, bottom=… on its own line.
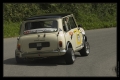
left=79, top=41, right=90, bottom=56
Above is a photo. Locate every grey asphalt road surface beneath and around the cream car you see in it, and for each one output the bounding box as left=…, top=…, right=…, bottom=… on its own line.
left=3, top=28, right=117, bottom=77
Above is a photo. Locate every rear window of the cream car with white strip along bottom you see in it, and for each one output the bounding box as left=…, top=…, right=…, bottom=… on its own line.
left=25, top=20, right=58, bottom=32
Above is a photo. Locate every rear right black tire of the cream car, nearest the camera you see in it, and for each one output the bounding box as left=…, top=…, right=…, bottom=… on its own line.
left=65, top=48, right=75, bottom=64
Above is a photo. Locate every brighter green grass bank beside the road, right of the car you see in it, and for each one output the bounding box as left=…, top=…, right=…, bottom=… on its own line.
left=77, top=12, right=117, bottom=30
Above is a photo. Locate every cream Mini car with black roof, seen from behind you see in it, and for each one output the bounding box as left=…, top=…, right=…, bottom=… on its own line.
left=15, top=14, right=90, bottom=64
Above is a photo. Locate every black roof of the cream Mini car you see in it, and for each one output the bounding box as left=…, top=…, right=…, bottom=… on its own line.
left=25, top=13, right=71, bottom=21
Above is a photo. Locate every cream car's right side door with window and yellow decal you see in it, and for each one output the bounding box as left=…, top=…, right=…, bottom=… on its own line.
left=62, top=16, right=82, bottom=50
